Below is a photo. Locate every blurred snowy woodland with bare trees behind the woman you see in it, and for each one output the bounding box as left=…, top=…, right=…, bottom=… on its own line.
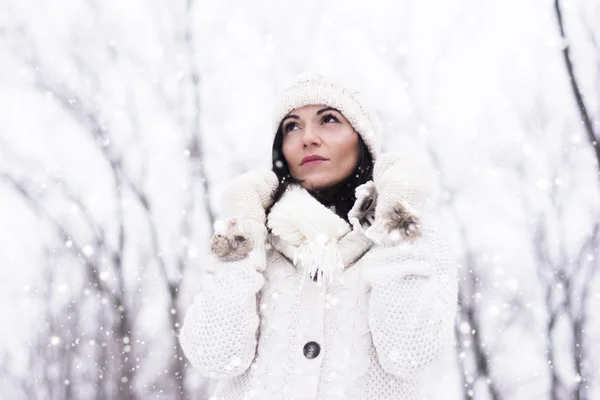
left=0, top=0, right=600, bottom=399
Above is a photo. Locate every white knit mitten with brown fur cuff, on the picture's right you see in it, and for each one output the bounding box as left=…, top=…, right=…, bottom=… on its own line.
left=366, top=153, right=433, bottom=247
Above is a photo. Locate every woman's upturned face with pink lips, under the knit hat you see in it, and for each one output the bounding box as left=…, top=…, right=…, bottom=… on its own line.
left=281, top=105, right=359, bottom=190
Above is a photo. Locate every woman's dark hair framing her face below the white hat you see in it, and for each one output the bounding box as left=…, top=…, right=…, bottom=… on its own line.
left=266, top=125, right=373, bottom=222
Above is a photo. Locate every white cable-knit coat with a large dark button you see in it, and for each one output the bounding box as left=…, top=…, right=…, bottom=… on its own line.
left=180, top=154, right=457, bottom=400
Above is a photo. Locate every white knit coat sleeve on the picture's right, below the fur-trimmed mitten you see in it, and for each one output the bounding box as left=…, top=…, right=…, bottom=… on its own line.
left=365, top=219, right=458, bottom=378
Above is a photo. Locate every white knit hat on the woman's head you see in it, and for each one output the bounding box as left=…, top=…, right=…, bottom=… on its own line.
left=273, top=72, right=381, bottom=162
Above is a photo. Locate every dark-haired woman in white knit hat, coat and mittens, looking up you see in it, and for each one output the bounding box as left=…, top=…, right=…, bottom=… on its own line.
left=180, top=74, right=457, bottom=400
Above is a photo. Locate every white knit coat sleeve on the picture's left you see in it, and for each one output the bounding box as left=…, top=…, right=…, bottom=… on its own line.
left=179, top=219, right=266, bottom=379
